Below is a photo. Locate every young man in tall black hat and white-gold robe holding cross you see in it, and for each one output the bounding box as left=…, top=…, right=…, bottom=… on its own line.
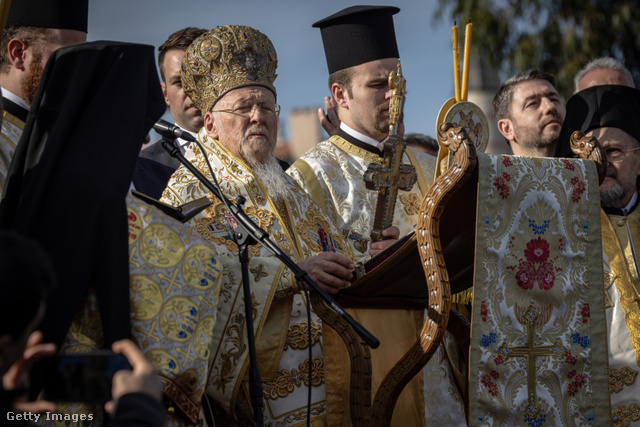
left=287, top=6, right=465, bottom=425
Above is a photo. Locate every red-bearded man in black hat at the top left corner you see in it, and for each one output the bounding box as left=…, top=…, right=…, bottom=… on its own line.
left=0, top=0, right=89, bottom=196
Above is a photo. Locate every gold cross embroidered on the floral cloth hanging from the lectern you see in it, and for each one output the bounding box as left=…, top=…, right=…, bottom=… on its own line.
left=498, top=305, right=567, bottom=419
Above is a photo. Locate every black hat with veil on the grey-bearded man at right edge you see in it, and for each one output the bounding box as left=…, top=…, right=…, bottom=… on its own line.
left=557, top=85, right=640, bottom=157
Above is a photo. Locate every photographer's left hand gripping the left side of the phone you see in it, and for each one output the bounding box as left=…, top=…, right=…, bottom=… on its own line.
left=2, top=331, right=56, bottom=414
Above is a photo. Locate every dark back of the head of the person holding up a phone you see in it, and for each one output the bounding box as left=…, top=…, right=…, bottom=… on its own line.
left=0, top=231, right=55, bottom=340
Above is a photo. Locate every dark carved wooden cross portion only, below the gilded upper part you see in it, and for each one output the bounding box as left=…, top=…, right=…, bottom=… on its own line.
left=364, top=135, right=418, bottom=242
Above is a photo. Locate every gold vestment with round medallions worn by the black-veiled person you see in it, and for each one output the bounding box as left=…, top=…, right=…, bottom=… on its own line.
left=45, top=195, right=222, bottom=426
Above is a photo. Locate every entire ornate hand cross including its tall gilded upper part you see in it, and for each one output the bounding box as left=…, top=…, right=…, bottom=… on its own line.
left=364, top=59, right=418, bottom=242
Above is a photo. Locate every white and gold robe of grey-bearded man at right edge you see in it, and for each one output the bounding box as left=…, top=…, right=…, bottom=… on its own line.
left=601, top=208, right=640, bottom=426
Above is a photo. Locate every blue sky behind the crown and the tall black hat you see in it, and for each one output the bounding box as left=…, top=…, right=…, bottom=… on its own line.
left=88, top=0, right=458, bottom=140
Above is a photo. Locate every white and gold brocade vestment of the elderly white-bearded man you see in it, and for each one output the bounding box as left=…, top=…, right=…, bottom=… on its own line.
left=162, top=130, right=353, bottom=426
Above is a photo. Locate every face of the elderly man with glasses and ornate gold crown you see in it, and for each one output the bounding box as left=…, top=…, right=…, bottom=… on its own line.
left=204, top=86, right=278, bottom=165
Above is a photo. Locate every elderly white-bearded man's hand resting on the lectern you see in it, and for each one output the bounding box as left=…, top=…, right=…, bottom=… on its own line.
left=298, top=252, right=355, bottom=294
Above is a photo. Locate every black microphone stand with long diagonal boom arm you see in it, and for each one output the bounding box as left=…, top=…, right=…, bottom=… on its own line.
left=162, top=139, right=380, bottom=426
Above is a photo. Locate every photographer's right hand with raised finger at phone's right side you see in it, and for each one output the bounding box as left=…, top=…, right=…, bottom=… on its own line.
left=104, top=340, right=162, bottom=414
